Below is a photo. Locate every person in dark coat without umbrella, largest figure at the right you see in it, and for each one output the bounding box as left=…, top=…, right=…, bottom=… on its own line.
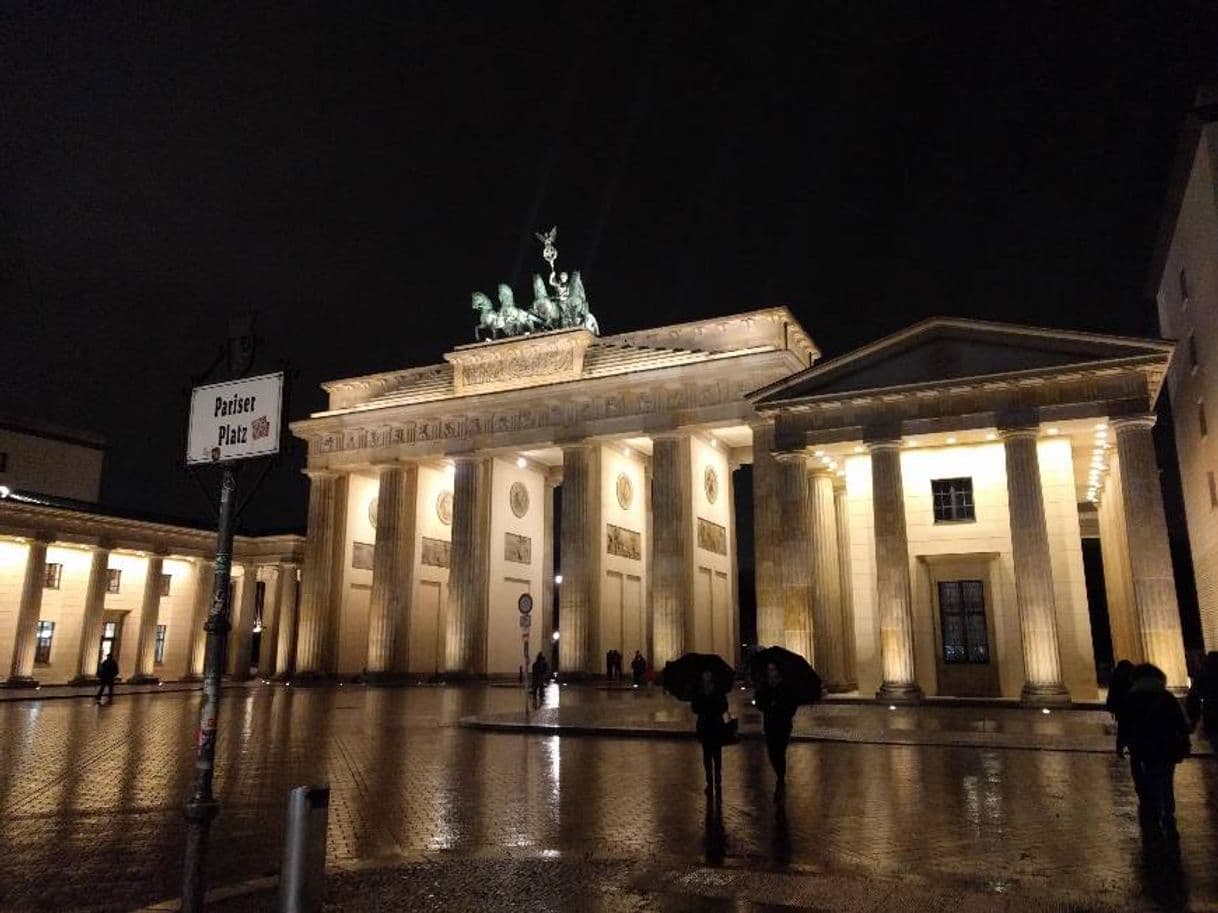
left=1123, top=663, right=1190, bottom=840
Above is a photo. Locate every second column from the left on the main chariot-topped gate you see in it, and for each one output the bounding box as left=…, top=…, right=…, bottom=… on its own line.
left=364, top=464, right=419, bottom=680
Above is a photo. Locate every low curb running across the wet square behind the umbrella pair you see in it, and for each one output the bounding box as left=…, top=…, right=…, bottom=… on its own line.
left=457, top=717, right=1209, bottom=758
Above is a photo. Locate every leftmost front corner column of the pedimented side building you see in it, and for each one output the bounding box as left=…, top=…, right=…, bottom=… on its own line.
left=775, top=450, right=820, bottom=666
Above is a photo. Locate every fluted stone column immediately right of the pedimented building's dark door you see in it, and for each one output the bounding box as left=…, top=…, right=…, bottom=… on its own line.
left=1001, top=426, right=1069, bottom=705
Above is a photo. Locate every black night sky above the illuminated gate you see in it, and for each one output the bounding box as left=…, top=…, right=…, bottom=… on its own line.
left=0, top=0, right=1218, bottom=528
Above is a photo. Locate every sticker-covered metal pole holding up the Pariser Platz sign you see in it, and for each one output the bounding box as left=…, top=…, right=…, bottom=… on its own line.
left=181, top=464, right=236, bottom=913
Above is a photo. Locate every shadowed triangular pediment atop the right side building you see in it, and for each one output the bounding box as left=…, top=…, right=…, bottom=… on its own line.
left=749, top=318, right=1173, bottom=407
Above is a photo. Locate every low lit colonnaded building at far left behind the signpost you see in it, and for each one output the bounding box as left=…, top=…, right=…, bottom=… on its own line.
left=0, top=488, right=305, bottom=688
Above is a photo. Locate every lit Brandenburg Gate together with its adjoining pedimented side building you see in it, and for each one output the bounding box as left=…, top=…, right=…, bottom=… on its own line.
left=280, top=308, right=1185, bottom=704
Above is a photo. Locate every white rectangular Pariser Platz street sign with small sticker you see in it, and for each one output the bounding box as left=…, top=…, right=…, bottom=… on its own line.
left=186, top=374, right=284, bottom=464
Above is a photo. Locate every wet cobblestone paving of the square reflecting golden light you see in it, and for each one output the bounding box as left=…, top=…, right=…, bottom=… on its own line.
left=0, top=685, right=1218, bottom=913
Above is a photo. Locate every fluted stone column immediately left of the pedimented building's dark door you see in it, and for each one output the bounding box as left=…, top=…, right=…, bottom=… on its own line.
left=868, top=441, right=922, bottom=701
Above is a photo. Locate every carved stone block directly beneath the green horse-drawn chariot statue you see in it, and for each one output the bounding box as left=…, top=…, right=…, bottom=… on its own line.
left=445, top=330, right=596, bottom=396
